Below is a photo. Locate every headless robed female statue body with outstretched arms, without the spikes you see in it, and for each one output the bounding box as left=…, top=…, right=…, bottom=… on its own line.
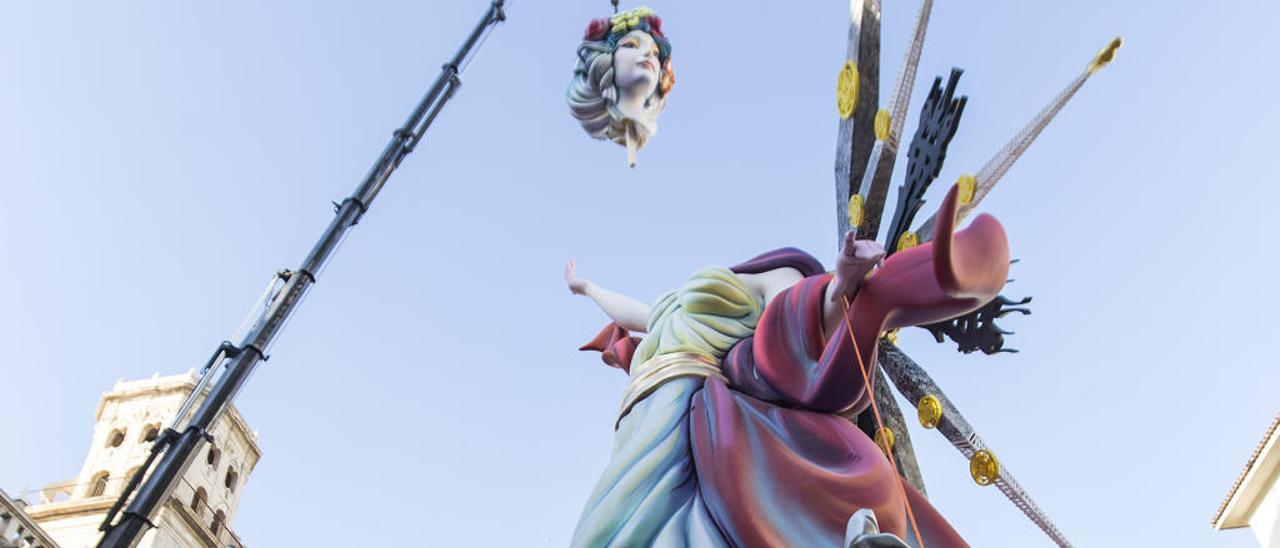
left=566, top=188, right=1009, bottom=548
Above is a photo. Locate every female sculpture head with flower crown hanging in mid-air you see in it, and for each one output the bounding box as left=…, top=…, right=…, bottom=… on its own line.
left=568, top=8, right=676, bottom=166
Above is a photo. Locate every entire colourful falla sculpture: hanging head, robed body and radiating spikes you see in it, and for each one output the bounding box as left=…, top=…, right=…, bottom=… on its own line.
left=564, top=0, right=1121, bottom=548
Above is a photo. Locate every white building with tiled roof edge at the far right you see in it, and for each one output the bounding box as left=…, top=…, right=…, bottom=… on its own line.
left=1213, top=415, right=1280, bottom=548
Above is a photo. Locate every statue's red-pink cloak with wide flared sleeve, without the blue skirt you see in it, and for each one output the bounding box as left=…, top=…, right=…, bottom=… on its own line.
left=584, top=188, right=1009, bottom=548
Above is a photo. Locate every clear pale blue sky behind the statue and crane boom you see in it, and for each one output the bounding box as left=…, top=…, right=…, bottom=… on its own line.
left=0, top=0, right=1280, bottom=547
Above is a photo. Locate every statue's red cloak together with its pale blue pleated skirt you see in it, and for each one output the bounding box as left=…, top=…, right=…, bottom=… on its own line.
left=573, top=188, right=1009, bottom=548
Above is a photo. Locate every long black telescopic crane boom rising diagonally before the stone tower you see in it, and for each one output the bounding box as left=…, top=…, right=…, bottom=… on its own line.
left=97, top=0, right=507, bottom=548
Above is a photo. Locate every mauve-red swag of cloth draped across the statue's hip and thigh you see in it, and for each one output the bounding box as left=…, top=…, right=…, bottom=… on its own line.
left=690, top=380, right=905, bottom=547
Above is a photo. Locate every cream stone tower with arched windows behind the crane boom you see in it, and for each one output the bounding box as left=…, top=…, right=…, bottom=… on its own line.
left=16, top=373, right=262, bottom=548
